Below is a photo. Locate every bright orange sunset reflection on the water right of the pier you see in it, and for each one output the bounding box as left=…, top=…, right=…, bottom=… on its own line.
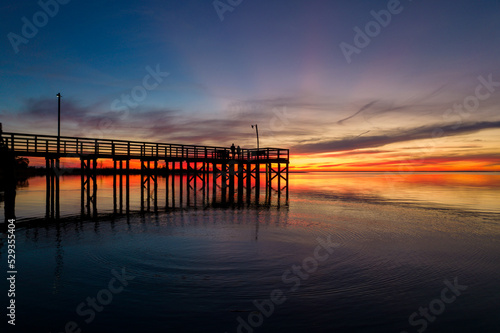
left=290, top=172, right=500, bottom=212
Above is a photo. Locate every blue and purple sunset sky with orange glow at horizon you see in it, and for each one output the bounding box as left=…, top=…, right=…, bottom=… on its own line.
left=0, top=0, right=500, bottom=171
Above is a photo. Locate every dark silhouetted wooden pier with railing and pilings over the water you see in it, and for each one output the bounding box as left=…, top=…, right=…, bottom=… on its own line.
left=1, top=132, right=289, bottom=219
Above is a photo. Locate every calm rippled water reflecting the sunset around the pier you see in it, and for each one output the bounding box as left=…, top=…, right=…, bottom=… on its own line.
left=0, top=173, right=500, bottom=333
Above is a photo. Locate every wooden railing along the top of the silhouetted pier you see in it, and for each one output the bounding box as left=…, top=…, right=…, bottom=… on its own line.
left=1, top=132, right=289, bottom=163
